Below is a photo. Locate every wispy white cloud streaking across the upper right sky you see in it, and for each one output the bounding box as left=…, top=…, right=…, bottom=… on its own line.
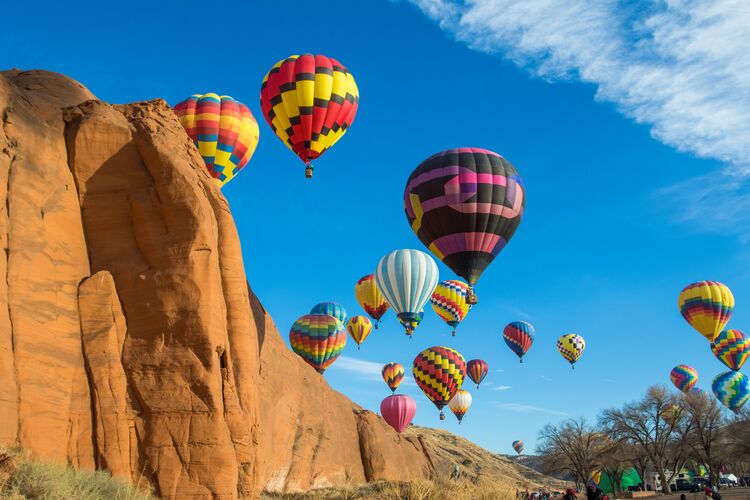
left=411, top=0, right=750, bottom=233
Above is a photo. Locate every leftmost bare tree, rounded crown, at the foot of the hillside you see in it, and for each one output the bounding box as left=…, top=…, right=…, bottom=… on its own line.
left=537, top=418, right=602, bottom=488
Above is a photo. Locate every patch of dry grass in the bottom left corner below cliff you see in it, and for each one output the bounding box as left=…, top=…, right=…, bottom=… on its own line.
left=0, top=450, right=154, bottom=500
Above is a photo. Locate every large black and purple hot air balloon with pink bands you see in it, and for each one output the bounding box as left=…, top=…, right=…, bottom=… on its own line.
left=404, top=148, right=526, bottom=304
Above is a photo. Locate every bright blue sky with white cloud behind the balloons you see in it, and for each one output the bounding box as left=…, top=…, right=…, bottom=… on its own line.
left=0, top=0, right=750, bottom=453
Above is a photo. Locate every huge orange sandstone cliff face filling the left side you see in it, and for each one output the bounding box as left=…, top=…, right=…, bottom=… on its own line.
left=0, top=70, right=433, bottom=498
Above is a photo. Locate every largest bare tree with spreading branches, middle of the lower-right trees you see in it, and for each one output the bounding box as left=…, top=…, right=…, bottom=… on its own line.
left=600, top=386, right=687, bottom=494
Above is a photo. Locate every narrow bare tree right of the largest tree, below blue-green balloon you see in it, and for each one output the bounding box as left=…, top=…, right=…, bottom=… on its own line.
left=683, top=394, right=728, bottom=484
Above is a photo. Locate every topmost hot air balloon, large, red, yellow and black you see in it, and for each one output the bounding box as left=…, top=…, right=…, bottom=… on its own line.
left=260, top=54, right=359, bottom=178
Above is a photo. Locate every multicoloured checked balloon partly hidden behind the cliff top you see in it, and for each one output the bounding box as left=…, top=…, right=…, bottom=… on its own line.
left=174, top=93, right=259, bottom=186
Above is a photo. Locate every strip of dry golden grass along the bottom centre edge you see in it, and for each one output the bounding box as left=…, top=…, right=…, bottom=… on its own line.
left=261, top=480, right=516, bottom=500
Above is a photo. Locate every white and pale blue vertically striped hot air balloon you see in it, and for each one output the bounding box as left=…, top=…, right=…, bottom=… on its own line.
left=375, top=250, right=438, bottom=335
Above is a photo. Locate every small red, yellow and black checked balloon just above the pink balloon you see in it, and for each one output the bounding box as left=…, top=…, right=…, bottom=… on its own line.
left=412, top=346, right=466, bottom=420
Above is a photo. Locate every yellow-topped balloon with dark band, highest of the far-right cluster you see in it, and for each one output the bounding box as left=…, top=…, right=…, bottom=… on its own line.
left=677, top=281, right=734, bottom=342
